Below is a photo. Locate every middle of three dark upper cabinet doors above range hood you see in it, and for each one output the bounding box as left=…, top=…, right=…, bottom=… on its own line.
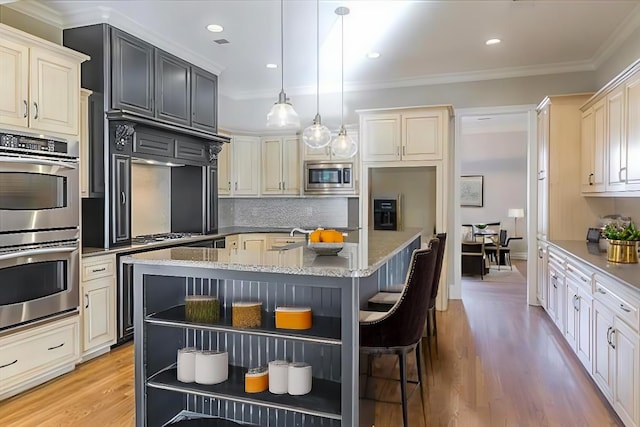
left=155, top=50, right=191, bottom=125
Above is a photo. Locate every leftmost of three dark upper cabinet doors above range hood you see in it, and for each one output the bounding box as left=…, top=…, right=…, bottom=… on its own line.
left=111, top=28, right=154, bottom=116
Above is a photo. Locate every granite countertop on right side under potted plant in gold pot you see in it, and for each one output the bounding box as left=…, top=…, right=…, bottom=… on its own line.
left=549, top=240, right=640, bottom=292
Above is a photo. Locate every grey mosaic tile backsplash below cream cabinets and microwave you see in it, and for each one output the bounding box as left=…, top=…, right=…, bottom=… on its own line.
left=218, top=197, right=357, bottom=228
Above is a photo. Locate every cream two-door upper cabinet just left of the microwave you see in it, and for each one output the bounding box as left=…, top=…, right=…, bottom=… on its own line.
left=260, top=136, right=302, bottom=196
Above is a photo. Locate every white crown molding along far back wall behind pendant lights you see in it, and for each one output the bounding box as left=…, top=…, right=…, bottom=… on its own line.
left=224, top=61, right=595, bottom=101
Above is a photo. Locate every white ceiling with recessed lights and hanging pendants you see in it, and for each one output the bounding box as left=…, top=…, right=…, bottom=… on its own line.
left=7, top=0, right=640, bottom=99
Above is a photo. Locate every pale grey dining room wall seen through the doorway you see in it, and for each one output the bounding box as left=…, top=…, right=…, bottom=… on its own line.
left=460, top=130, right=528, bottom=258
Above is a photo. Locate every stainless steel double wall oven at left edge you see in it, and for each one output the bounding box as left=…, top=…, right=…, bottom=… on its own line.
left=0, top=130, right=80, bottom=330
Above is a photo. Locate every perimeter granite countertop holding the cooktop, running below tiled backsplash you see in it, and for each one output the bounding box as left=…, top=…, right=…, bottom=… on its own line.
left=82, top=227, right=358, bottom=258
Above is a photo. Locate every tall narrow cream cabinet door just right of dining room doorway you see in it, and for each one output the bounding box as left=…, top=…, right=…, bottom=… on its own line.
left=537, top=105, right=549, bottom=240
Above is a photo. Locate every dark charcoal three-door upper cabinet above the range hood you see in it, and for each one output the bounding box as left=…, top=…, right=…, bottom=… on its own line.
left=64, top=24, right=218, bottom=137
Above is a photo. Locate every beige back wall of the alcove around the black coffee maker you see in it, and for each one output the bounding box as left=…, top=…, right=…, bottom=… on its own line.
left=369, top=167, right=436, bottom=237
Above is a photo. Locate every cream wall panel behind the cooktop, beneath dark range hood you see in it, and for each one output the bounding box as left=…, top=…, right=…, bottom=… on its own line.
left=131, top=163, right=171, bottom=237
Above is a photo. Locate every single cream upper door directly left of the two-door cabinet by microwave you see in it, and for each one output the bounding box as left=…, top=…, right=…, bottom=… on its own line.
left=232, top=136, right=260, bottom=196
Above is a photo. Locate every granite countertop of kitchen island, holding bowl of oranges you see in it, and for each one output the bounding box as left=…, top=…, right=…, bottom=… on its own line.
left=123, top=228, right=422, bottom=277
